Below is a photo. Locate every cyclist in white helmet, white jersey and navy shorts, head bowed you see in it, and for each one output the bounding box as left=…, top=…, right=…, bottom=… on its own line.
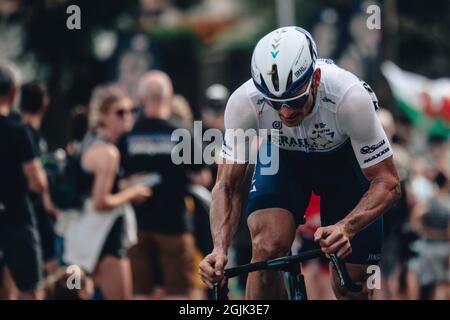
left=199, top=26, right=400, bottom=299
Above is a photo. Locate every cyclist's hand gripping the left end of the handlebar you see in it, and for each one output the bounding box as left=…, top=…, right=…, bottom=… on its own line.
left=198, top=251, right=228, bottom=288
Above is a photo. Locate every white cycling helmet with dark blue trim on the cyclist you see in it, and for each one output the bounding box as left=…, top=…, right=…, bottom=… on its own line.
left=251, top=26, right=317, bottom=99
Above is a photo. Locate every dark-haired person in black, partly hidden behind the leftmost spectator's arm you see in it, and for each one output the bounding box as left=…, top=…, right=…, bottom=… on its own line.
left=20, top=81, right=58, bottom=273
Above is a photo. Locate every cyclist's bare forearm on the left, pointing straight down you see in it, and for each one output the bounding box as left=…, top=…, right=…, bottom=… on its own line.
left=211, top=182, right=241, bottom=254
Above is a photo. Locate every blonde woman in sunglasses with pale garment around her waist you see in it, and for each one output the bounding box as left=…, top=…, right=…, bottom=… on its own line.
left=64, top=87, right=150, bottom=299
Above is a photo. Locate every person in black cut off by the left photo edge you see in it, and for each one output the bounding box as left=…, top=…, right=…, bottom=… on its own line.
left=0, top=65, right=48, bottom=299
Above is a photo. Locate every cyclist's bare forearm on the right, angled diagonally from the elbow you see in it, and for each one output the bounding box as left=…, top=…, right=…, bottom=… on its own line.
left=339, top=179, right=400, bottom=238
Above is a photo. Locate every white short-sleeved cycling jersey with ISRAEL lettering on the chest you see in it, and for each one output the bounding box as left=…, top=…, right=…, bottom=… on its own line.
left=221, top=59, right=392, bottom=168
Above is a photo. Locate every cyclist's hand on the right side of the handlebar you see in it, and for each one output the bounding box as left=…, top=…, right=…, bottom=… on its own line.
left=314, top=224, right=352, bottom=259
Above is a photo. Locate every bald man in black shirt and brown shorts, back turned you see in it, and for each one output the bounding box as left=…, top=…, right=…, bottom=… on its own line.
left=121, top=71, right=195, bottom=298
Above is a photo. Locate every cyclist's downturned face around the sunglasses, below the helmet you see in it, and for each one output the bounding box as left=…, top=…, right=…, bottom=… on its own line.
left=278, top=69, right=320, bottom=127
